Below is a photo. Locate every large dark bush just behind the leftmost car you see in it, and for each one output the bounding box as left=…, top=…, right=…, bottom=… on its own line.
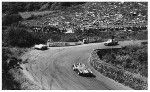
left=6, top=27, right=42, bottom=47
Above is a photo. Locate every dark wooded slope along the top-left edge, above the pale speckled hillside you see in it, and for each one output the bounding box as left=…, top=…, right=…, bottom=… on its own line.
left=2, top=2, right=84, bottom=14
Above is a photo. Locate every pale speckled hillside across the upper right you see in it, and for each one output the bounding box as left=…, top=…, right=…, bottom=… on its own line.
left=22, top=2, right=148, bottom=29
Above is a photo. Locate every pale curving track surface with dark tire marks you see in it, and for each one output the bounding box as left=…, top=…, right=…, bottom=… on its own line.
left=22, top=41, right=145, bottom=90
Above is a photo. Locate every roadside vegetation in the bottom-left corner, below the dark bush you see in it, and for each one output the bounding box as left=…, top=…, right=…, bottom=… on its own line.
left=2, top=68, right=40, bottom=90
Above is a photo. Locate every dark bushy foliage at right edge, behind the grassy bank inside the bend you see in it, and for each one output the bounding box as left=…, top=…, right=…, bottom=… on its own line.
left=102, top=45, right=148, bottom=77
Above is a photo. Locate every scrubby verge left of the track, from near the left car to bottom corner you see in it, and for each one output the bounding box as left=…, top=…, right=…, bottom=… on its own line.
left=2, top=47, right=39, bottom=90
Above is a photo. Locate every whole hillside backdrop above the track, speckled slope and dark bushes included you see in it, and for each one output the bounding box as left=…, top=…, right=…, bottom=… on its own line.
left=2, top=2, right=148, bottom=45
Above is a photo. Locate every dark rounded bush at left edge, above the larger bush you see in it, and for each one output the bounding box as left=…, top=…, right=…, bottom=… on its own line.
left=2, top=14, right=22, bottom=26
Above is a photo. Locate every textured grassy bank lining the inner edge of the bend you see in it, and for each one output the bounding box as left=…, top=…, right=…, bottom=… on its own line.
left=90, top=46, right=148, bottom=90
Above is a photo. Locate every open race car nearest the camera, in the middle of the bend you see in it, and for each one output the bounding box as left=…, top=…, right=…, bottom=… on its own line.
left=73, top=63, right=93, bottom=77
